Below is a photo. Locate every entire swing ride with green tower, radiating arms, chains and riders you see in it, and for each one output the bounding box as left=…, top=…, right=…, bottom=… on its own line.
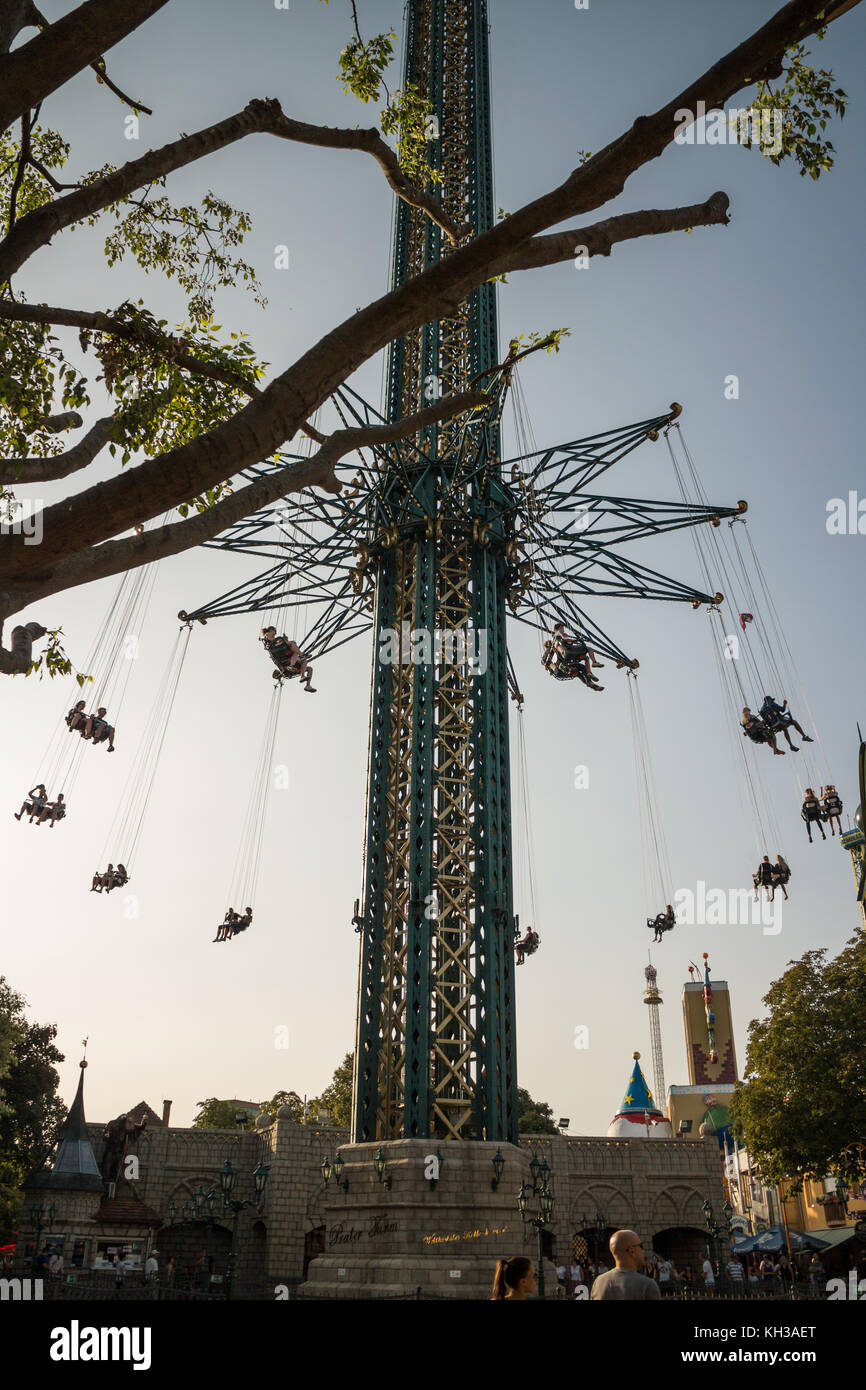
left=13, top=0, right=841, bottom=1143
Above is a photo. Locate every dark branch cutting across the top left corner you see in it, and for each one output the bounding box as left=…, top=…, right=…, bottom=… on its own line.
left=0, top=0, right=167, bottom=131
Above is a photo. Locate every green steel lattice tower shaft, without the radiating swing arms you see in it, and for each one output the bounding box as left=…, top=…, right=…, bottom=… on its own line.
left=353, top=0, right=517, bottom=1141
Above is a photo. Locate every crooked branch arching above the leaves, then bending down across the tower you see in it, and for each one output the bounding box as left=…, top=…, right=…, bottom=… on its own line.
left=0, top=97, right=467, bottom=284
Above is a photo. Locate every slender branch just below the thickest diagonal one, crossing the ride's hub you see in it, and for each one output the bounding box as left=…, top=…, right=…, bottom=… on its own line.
left=10, top=391, right=489, bottom=612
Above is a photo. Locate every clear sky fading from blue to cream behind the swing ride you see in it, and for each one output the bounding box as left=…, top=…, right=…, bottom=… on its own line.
left=0, top=0, right=866, bottom=1134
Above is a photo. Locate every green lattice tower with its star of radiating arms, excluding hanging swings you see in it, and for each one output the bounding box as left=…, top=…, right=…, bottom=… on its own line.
left=181, top=0, right=744, bottom=1143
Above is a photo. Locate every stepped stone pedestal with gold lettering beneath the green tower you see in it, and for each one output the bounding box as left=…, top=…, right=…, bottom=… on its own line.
left=299, top=1138, right=556, bottom=1298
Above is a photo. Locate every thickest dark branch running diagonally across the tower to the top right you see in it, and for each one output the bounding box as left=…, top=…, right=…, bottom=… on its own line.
left=0, top=0, right=861, bottom=619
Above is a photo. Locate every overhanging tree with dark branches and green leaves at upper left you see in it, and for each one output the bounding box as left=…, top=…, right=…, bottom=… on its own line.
left=0, top=0, right=856, bottom=675
